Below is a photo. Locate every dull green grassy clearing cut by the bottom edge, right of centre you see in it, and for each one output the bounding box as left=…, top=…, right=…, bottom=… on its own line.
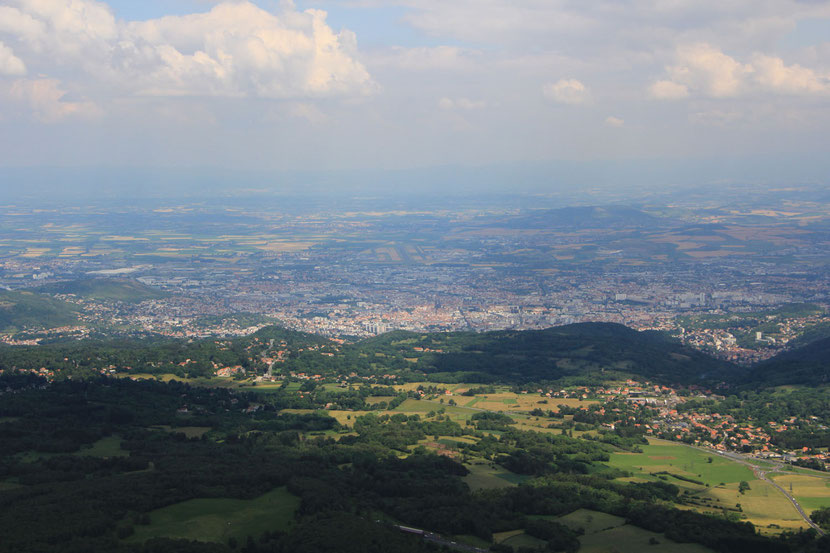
left=579, top=524, right=712, bottom=553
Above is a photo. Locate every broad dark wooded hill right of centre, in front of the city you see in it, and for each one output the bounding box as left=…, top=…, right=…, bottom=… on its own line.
left=358, top=323, right=741, bottom=384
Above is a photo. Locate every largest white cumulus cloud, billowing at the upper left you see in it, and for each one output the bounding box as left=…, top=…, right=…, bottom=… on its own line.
left=0, top=0, right=375, bottom=99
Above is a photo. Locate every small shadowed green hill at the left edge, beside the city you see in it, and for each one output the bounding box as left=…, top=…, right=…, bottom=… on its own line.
left=0, top=290, right=78, bottom=332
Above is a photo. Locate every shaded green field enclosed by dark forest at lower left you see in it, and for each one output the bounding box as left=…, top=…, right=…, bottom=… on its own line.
left=127, top=488, right=300, bottom=543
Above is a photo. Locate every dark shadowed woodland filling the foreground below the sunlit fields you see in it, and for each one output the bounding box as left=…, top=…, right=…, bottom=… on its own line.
left=0, top=374, right=828, bottom=553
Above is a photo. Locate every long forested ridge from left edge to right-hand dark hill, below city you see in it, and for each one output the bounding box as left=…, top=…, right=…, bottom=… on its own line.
left=0, top=323, right=744, bottom=385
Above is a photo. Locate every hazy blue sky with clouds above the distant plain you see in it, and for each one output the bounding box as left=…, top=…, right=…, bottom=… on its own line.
left=0, top=0, right=830, bottom=186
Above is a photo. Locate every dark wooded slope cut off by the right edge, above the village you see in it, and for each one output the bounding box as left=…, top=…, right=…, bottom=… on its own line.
left=749, top=338, right=830, bottom=386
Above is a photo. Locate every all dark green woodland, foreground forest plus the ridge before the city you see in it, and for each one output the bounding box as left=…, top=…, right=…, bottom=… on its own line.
left=0, top=325, right=830, bottom=553
